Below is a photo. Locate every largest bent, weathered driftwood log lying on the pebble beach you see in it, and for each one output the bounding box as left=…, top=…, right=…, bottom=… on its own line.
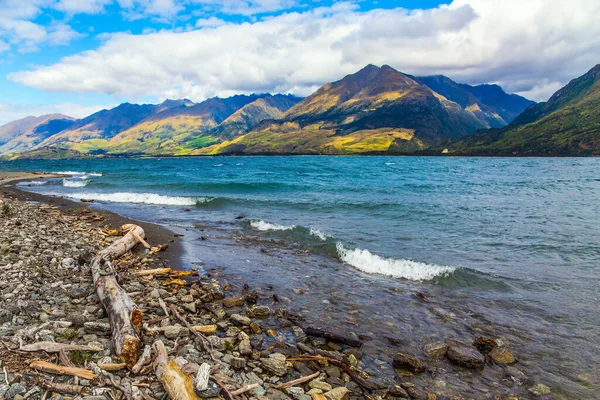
left=91, top=224, right=145, bottom=368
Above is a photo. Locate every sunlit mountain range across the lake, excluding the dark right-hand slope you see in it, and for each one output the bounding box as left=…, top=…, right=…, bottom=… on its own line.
left=0, top=65, right=552, bottom=159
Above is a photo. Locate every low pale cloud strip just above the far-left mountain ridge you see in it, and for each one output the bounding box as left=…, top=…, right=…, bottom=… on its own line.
left=0, top=103, right=116, bottom=126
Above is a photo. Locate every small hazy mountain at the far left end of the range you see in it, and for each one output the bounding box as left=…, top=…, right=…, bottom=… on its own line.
left=0, top=114, right=76, bottom=154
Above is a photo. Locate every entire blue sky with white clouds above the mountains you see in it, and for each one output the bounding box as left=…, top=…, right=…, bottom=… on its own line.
left=0, top=0, right=600, bottom=124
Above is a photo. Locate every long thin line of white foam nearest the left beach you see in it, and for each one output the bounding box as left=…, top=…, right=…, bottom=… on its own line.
left=58, top=192, right=212, bottom=206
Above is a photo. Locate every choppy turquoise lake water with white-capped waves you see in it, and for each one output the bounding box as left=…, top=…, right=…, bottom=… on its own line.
left=0, top=157, right=600, bottom=398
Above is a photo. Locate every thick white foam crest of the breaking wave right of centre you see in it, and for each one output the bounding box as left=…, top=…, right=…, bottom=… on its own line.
left=337, top=243, right=455, bottom=281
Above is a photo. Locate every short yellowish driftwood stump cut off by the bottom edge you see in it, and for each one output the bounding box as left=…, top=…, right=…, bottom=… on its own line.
left=152, top=340, right=200, bottom=400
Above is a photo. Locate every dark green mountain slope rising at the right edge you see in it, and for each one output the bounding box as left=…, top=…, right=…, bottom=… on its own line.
left=440, top=64, right=600, bottom=156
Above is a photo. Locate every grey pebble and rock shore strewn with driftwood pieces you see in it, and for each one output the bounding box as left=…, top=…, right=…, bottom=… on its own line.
left=0, top=173, right=394, bottom=400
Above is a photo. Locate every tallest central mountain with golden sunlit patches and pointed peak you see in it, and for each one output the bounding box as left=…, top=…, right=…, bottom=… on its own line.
left=195, top=65, right=516, bottom=154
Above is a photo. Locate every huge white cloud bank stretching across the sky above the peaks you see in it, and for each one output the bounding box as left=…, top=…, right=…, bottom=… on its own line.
left=9, top=0, right=600, bottom=101
